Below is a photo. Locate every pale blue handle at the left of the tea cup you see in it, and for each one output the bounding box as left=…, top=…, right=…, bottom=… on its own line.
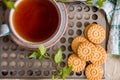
left=0, top=24, right=10, bottom=37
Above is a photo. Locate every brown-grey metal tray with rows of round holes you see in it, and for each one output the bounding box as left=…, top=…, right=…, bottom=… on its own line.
left=0, top=2, right=108, bottom=79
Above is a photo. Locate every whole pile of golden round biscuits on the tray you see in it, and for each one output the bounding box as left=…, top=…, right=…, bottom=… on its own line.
left=68, top=24, right=107, bottom=80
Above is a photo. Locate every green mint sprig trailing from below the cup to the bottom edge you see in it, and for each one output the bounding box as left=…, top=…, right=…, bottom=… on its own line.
left=29, top=45, right=72, bottom=80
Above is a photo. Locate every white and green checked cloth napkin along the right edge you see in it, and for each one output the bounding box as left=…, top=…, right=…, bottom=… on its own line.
left=89, top=0, right=120, bottom=55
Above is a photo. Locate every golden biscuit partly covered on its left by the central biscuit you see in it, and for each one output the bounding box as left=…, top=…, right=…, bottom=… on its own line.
left=91, top=45, right=107, bottom=65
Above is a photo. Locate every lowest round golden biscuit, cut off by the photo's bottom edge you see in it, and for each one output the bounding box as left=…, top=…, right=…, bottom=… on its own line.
left=85, top=64, right=103, bottom=80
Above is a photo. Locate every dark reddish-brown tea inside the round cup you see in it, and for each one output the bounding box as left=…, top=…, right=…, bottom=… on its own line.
left=13, top=0, right=60, bottom=42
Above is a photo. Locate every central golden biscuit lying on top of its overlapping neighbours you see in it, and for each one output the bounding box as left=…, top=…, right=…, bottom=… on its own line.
left=77, top=42, right=96, bottom=61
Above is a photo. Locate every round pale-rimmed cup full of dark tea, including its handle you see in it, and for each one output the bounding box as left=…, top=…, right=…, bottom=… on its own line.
left=0, top=0, right=68, bottom=49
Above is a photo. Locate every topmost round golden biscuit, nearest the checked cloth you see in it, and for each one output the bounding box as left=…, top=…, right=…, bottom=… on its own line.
left=85, top=24, right=106, bottom=44
